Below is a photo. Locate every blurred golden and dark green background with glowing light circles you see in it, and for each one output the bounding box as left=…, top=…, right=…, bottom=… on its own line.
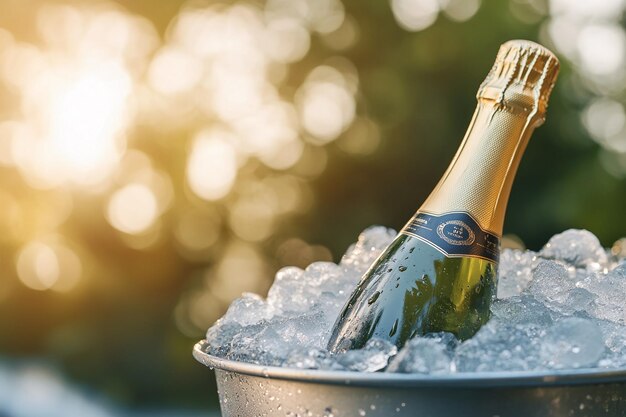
left=0, top=0, right=626, bottom=417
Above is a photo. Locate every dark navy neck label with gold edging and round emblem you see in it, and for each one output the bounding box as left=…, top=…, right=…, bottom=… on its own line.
left=400, top=211, right=500, bottom=263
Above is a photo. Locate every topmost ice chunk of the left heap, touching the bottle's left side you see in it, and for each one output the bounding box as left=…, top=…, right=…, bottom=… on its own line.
left=341, top=226, right=397, bottom=273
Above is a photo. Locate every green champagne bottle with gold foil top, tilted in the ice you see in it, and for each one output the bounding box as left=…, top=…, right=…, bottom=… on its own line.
left=328, top=40, right=559, bottom=352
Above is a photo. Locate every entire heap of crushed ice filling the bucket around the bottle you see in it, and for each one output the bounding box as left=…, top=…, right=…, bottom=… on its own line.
left=207, top=226, right=626, bottom=374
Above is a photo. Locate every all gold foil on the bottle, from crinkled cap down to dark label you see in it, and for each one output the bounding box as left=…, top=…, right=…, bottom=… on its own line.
left=419, top=40, right=559, bottom=236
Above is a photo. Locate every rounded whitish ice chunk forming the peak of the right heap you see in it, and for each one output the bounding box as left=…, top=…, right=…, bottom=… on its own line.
left=539, top=229, right=608, bottom=270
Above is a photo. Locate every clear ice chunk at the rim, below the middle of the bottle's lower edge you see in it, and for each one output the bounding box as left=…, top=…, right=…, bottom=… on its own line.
left=387, top=333, right=456, bottom=374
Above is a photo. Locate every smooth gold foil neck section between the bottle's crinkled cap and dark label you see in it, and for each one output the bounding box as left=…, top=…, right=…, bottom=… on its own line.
left=419, top=97, right=543, bottom=236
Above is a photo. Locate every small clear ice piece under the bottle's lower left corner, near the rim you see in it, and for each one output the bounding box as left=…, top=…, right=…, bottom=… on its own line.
left=336, top=339, right=398, bottom=372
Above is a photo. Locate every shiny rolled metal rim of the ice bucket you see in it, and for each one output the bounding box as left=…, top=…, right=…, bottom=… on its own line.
left=193, top=340, right=626, bottom=388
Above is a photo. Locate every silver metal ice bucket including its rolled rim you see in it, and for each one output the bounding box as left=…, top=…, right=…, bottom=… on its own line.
left=193, top=342, right=626, bottom=417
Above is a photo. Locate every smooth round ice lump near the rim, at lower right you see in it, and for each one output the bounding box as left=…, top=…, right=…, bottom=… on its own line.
left=540, top=317, right=605, bottom=369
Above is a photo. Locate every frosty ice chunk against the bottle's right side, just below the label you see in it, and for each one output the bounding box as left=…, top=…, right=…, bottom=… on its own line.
left=498, top=249, right=537, bottom=298
